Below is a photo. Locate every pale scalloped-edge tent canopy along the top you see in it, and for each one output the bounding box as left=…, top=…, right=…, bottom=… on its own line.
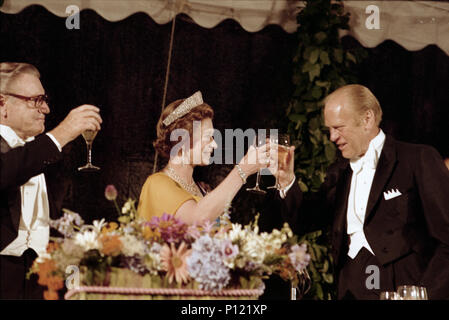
left=0, top=0, right=449, bottom=55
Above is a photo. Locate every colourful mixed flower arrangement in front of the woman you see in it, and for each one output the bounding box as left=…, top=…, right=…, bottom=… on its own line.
left=30, top=186, right=310, bottom=299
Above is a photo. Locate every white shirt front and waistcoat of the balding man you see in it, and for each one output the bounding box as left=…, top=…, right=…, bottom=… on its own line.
left=347, top=130, right=385, bottom=259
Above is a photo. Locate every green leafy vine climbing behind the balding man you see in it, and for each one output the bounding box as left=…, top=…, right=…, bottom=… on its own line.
left=286, top=0, right=366, bottom=300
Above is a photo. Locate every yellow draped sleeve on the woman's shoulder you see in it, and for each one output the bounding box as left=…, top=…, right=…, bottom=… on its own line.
left=137, top=172, right=199, bottom=221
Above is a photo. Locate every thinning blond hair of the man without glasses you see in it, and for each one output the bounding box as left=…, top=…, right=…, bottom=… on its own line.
left=324, top=84, right=382, bottom=126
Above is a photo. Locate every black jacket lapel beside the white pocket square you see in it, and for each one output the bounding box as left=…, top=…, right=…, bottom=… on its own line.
left=365, top=135, right=397, bottom=224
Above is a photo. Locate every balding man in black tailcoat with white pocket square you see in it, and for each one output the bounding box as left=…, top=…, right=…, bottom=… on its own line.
left=270, top=85, right=449, bottom=299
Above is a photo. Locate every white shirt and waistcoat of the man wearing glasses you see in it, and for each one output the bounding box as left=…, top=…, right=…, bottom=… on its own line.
left=0, top=125, right=61, bottom=257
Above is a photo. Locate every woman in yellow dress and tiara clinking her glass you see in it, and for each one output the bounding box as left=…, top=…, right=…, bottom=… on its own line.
left=138, top=91, right=269, bottom=224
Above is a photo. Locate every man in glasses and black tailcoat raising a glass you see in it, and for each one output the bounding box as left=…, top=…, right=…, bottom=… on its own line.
left=0, top=62, right=102, bottom=299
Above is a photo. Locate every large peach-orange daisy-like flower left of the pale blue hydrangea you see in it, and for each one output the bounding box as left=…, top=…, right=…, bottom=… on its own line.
left=160, top=242, right=192, bottom=283
